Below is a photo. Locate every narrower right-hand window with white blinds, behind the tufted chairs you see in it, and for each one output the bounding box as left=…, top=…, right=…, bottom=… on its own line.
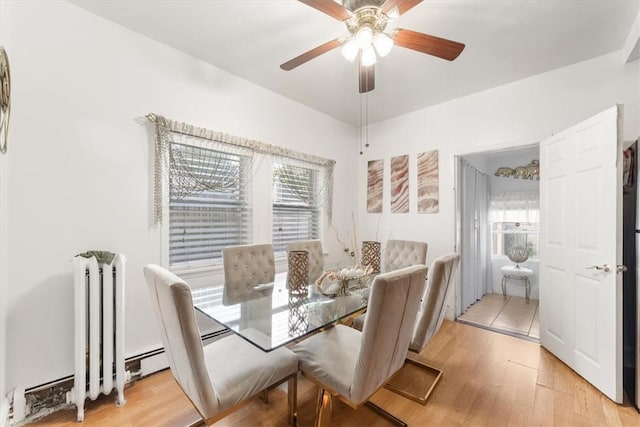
left=272, top=163, right=320, bottom=253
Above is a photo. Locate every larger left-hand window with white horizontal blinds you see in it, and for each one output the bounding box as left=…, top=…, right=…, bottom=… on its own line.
left=169, top=143, right=251, bottom=267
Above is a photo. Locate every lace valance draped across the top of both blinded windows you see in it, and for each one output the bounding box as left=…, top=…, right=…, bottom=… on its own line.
left=146, top=113, right=335, bottom=224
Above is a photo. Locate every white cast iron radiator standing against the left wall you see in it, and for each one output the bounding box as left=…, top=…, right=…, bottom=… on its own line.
left=67, top=254, right=128, bottom=421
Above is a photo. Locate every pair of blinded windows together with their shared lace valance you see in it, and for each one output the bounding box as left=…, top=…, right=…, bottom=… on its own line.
left=152, top=114, right=335, bottom=270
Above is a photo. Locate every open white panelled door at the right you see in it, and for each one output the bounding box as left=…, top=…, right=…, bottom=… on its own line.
left=540, top=107, right=622, bottom=403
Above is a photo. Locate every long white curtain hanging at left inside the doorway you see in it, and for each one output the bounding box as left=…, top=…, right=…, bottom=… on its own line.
left=460, top=160, right=491, bottom=313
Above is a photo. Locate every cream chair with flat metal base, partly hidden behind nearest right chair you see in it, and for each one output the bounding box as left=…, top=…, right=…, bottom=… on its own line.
left=386, top=253, right=460, bottom=405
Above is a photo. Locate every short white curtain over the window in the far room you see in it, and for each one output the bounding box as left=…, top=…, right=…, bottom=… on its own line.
left=489, top=190, right=540, bottom=222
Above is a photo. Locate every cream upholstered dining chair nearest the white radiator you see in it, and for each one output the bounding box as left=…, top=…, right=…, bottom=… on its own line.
left=144, top=265, right=298, bottom=425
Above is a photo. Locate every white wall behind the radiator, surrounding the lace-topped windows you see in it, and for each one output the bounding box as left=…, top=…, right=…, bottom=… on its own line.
left=0, top=1, right=358, bottom=390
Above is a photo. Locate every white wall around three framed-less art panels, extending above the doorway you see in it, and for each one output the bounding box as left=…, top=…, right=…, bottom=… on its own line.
left=358, top=48, right=640, bottom=300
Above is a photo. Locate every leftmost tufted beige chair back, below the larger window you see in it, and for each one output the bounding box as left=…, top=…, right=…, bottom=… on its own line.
left=222, top=243, right=276, bottom=305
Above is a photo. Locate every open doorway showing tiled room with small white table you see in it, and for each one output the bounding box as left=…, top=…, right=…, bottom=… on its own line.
left=456, top=144, right=540, bottom=341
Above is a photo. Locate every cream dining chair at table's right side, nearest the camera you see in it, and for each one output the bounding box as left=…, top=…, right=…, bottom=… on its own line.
left=292, top=265, right=426, bottom=426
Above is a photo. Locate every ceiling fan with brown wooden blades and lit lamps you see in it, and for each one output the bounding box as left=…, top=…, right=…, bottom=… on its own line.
left=280, top=0, right=464, bottom=93
